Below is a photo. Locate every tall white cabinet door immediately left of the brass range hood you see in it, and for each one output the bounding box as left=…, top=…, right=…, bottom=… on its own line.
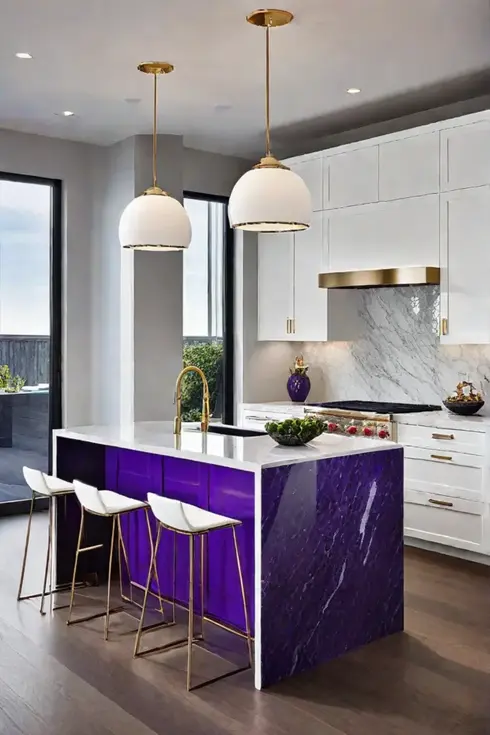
left=294, top=212, right=327, bottom=342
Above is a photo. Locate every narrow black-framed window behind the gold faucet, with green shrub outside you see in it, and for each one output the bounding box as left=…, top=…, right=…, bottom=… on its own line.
left=182, top=194, right=233, bottom=423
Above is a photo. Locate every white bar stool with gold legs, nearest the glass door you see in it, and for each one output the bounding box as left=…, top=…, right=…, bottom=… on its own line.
left=17, top=467, right=74, bottom=615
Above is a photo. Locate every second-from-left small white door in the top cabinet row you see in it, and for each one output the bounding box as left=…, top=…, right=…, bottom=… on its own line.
left=323, top=145, right=378, bottom=209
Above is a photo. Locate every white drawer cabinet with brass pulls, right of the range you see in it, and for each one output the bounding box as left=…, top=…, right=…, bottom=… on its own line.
left=398, top=424, right=490, bottom=554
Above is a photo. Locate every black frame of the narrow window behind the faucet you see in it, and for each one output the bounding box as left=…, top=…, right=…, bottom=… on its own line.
left=183, top=191, right=235, bottom=424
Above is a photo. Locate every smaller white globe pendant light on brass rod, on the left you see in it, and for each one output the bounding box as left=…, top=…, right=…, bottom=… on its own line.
left=119, top=61, right=192, bottom=252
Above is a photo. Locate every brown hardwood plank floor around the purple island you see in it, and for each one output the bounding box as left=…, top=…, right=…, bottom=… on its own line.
left=0, top=514, right=490, bottom=735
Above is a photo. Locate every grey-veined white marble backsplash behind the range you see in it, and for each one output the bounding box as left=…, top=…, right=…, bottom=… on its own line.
left=302, top=286, right=490, bottom=414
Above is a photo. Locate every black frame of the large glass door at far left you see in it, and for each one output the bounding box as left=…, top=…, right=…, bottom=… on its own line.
left=0, top=171, right=63, bottom=517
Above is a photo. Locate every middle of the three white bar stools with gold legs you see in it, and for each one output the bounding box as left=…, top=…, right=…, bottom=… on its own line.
left=66, top=480, right=164, bottom=640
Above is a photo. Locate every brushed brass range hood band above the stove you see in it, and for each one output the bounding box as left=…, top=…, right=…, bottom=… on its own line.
left=318, top=265, right=441, bottom=288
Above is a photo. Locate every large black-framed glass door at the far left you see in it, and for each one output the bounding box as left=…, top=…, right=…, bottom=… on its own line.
left=0, top=174, right=61, bottom=515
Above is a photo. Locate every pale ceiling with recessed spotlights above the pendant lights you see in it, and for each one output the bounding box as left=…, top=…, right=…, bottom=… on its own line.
left=0, top=0, right=490, bottom=157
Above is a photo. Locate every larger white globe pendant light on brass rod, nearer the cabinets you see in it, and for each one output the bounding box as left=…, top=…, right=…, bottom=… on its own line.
left=228, top=10, right=312, bottom=232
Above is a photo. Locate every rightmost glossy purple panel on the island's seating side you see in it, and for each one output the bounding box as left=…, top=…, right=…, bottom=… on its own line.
left=205, top=465, right=255, bottom=630
